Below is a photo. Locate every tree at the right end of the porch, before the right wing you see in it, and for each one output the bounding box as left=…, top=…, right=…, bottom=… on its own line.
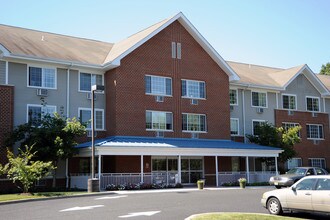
left=247, top=123, right=301, bottom=162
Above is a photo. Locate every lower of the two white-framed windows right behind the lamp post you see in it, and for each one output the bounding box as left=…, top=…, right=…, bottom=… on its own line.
left=78, top=108, right=104, bottom=130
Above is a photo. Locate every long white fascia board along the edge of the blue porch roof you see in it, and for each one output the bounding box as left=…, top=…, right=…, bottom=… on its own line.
left=79, top=146, right=283, bottom=157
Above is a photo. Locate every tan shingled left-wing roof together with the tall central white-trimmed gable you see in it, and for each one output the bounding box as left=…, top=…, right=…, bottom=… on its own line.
left=0, top=12, right=239, bottom=80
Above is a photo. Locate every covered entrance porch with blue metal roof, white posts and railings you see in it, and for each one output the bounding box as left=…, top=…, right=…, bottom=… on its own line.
left=70, top=137, right=281, bottom=189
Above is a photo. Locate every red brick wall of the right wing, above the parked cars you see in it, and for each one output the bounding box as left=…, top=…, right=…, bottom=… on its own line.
left=275, top=110, right=330, bottom=167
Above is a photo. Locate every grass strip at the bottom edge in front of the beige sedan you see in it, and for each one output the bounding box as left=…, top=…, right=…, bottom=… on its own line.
left=191, top=212, right=300, bottom=220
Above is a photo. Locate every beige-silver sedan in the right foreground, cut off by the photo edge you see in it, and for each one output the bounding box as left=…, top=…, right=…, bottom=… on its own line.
left=261, top=175, right=330, bottom=215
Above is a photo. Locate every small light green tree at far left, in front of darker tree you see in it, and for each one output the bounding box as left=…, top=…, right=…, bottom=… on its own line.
left=0, top=146, right=55, bottom=193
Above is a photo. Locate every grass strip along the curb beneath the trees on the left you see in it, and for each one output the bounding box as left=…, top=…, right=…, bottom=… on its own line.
left=0, top=191, right=87, bottom=203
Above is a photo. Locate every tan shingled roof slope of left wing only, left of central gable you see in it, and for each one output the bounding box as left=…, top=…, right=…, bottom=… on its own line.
left=0, top=25, right=113, bottom=65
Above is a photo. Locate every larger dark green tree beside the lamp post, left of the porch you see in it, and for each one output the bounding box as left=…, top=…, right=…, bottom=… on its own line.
left=6, top=113, right=86, bottom=187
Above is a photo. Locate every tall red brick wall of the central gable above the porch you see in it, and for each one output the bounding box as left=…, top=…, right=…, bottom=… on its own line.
left=105, top=21, right=230, bottom=139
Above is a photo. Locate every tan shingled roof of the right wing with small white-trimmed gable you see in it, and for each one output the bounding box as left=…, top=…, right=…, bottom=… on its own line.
left=227, top=61, right=329, bottom=95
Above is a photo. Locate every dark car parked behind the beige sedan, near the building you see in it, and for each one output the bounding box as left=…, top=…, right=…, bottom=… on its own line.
left=269, top=167, right=328, bottom=189
